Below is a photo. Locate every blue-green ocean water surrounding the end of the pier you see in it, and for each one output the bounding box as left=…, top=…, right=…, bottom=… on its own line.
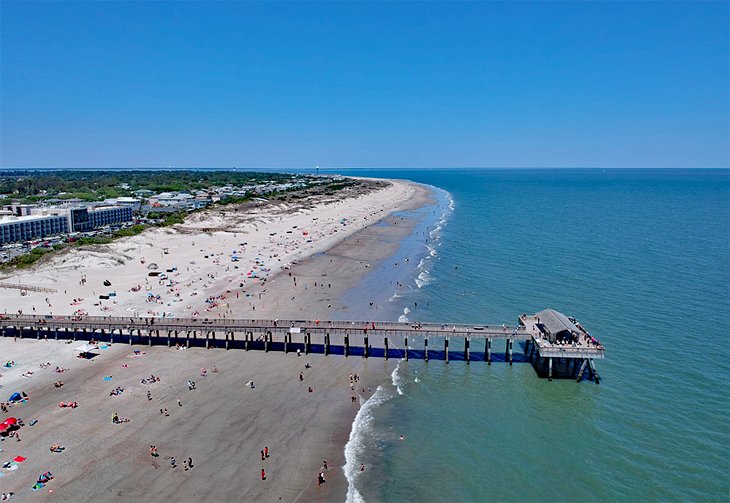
left=332, top=169, right=730, bottom=502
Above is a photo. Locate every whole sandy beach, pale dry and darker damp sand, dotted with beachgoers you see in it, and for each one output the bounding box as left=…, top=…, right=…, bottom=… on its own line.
left=0, top=181, right=429, bottom=501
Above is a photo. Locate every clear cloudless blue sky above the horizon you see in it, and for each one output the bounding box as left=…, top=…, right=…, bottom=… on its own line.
left=0, top=0, right=730, bottom=168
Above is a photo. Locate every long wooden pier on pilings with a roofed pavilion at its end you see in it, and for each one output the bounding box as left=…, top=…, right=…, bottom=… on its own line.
left=0, top=309, right=605, bottom=383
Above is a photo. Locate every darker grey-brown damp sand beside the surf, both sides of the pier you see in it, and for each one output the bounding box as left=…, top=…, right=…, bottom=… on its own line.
left=0, top=179, right=429, bottom=501
